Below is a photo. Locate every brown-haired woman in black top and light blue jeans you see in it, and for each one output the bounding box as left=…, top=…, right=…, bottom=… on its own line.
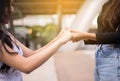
left=70, top=0, right=120, bottom=81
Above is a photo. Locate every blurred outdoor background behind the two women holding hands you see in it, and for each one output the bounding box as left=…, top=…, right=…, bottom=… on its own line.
left=6, top=0, right=107, bottom=81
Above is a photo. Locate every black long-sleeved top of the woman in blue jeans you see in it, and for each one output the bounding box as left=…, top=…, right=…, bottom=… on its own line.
left=85, top=16, right=120, bottom=44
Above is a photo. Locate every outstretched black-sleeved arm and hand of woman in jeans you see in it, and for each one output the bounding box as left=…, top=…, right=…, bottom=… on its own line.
left=70, top=29, right=120, bottom=44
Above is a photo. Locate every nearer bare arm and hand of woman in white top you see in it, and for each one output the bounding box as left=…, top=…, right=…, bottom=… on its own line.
left=0, top=31, right=72, bottom=73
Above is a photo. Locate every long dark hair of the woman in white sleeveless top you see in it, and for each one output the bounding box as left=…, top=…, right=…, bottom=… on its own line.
left=0, top=0, right=17, bottom=72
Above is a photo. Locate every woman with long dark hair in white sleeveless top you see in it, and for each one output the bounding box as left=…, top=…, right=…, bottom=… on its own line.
left=0, top=0, right=72, bottom=81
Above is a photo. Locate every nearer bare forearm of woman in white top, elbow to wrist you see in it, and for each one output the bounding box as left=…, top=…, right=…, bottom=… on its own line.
left=22, top=41, right=62, bottom=73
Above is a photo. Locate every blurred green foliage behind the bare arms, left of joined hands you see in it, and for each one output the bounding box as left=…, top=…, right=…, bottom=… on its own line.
left=29, top=23, right=58, bottom=46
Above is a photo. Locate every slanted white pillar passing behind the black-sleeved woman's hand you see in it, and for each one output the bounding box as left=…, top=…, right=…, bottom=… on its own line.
left=60, top=0, right=107, bottom=51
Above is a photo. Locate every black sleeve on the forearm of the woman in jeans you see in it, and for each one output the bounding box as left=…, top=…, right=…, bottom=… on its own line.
left=85, top=32, right=120, bottom=44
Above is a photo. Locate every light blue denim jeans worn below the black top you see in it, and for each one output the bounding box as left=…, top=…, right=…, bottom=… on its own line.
left=94, top=45, right=120, bottom=81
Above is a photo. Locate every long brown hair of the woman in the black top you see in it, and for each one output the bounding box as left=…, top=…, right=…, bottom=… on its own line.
left=100, top=0, right=120, bottom=30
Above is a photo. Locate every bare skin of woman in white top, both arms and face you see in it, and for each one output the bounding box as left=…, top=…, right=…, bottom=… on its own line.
left=0, top=0, right=72, bottom=74
